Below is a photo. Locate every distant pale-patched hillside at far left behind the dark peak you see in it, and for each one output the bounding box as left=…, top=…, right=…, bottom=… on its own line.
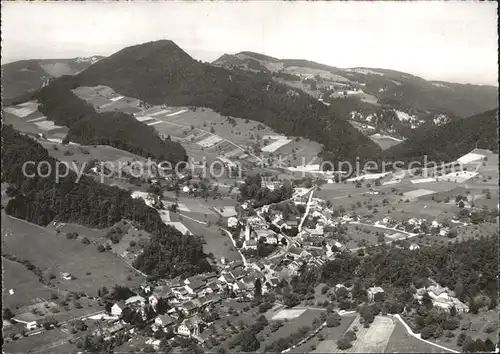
left=2, top=56, right=103, bottom=106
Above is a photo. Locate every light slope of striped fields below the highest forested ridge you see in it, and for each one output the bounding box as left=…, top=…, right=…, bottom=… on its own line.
left=75, top=86, right=321, bottom=169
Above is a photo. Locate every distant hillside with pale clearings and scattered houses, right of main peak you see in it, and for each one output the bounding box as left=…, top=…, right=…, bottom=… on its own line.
left=213, top=52, right=498, bottom=137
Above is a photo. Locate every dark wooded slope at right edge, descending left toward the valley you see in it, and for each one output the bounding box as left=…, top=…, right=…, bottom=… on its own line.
left=384, top=109, right=498, bottom=162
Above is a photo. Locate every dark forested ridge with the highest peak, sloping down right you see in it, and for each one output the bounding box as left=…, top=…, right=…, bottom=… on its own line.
left=75, top=40, right=380, bottom=165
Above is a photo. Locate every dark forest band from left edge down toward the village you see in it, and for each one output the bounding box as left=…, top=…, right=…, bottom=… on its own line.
left=2, top=126, right=210, bottom=277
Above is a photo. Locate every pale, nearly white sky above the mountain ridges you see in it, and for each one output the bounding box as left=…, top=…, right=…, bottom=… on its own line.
left=2, top=1, right=498, bottom=86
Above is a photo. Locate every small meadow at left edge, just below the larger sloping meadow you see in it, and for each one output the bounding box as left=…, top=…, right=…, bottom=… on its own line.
left=2, top=258, right=52, bottom=309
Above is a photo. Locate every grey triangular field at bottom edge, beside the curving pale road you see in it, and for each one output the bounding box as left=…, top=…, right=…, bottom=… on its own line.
left=384, top=321, right=449, bottom=353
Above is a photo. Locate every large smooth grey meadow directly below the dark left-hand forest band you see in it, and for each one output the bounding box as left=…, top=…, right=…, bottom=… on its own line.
left=2, top=212, right=143, bottom=296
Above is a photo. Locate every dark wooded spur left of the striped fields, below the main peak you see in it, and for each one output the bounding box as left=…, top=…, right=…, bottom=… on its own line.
left=37, top=76, right=187, bottom=163
